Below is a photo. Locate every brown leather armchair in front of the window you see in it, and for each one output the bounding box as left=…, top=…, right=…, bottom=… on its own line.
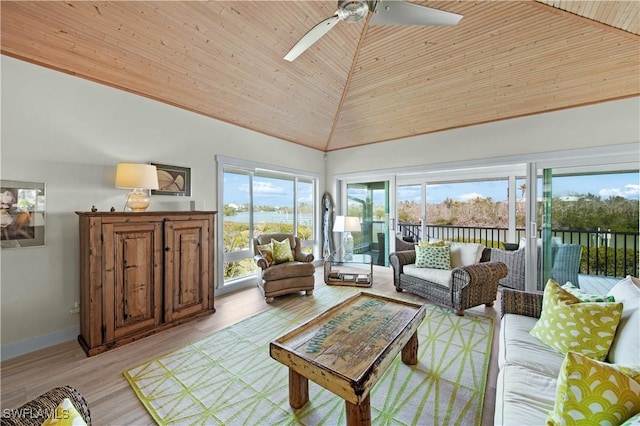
left=253, top=233, right=315, bottom=303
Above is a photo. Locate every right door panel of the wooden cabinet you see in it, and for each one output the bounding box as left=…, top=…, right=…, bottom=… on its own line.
left=165, top=220, right=210, bottom=321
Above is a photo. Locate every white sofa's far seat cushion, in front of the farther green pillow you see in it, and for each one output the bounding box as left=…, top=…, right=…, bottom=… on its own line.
left=498, top=314, right=564, bottom=378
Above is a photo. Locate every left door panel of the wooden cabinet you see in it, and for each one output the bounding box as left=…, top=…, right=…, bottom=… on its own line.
left=103, top=222, right=162, bottom=342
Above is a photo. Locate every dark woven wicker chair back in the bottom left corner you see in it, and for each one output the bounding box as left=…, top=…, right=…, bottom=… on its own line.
left=0, top=386, right=91, bottom=426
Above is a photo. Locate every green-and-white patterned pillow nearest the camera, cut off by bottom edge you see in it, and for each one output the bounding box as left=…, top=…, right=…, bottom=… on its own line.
left=547, top=352, right=640, bottom=425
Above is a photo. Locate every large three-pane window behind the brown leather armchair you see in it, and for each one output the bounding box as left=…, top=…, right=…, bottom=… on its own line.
left=218, top=158, right=318, bottom=288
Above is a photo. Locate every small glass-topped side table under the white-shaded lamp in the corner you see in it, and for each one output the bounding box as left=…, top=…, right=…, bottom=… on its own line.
left=324, top=254, right=373, bottom=287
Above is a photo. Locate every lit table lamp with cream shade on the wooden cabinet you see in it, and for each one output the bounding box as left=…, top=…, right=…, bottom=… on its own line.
left=116, top=163, right=158, bottom=212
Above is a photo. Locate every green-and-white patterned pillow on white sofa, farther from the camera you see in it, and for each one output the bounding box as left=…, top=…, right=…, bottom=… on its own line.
left=529, top=279, right=622, bottom=361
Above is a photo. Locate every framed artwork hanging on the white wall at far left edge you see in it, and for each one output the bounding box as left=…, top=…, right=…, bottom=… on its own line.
left=0, top=179, right=45, bottom=248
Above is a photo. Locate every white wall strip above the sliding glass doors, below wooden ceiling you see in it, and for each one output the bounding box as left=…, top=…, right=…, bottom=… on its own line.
left=327, top=97, right=640, bottom=177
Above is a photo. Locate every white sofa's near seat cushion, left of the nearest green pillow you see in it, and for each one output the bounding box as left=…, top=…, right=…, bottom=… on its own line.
left=493, top=365, right=556, bottom=426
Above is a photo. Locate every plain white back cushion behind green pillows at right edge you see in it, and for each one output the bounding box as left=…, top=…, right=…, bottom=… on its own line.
left=607, top=275, right=640, bottom=365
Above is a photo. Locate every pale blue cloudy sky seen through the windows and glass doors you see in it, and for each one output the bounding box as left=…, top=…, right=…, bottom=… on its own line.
left=224, top=172, right=640, bottom=206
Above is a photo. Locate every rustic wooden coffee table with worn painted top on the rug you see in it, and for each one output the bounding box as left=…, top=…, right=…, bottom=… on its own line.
left=269, top=293, right=425, bottom=425
